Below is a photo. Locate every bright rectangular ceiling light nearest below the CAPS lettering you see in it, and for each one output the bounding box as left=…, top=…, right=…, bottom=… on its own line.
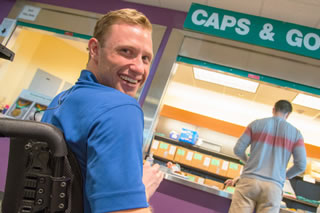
left=193, top=67, right=259, bottom=93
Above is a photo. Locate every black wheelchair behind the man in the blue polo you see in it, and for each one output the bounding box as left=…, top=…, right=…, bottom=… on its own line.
left=0, top=118, right=83, bottom=213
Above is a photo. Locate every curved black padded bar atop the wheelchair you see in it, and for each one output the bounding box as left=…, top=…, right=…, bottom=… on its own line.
left=0, top=118, right=68, bottom=157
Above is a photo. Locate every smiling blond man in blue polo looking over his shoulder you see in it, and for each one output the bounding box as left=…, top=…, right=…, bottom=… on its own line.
left=42, top=9, right=163, bottom=213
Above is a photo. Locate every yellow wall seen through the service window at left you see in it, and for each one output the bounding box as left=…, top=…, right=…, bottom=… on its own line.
left=0, top=29, right=88, bottom=105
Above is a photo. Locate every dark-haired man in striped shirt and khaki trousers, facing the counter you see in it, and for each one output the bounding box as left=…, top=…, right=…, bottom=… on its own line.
left=229, top=100, right=307, bottom=213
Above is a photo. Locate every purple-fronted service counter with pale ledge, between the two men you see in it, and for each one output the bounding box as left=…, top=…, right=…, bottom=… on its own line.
left=150, top=173, right=317, bottom=213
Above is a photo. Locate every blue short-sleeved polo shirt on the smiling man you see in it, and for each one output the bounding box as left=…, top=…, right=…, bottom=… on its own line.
left=42, top=70, right=148, bottom=213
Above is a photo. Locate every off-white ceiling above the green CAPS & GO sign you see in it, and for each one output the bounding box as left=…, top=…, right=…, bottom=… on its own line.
left=125, top=0, right=320, bottom=29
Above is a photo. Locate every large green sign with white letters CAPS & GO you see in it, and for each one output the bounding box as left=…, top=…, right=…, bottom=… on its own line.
left=184, top=3, right=320, bottom=59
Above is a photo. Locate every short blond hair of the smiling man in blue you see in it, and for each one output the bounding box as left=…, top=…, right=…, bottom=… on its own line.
left=93, top=8, right=152, bottom=45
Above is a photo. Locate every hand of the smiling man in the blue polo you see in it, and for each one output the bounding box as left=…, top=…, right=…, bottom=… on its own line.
left=142, top=161, right=163, bottom=202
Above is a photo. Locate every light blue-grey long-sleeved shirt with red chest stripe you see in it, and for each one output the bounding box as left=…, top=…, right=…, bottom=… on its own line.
left=234, top=116, right=306, bottom=187
